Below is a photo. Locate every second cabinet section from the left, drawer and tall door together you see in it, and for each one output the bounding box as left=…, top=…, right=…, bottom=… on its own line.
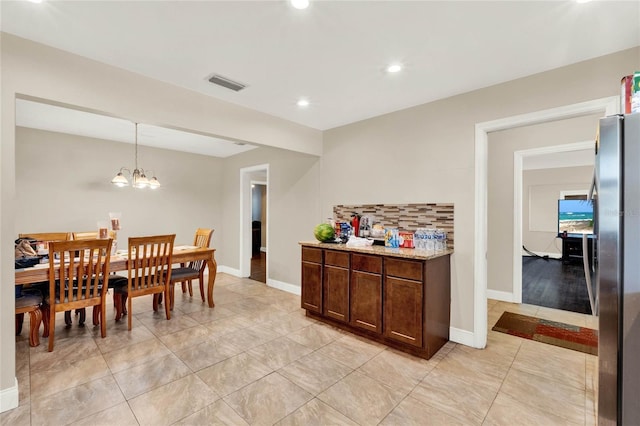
left=322, top=250, right=349, bottom=322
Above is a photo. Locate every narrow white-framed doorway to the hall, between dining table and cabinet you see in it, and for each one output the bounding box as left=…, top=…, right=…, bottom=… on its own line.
left=240, top=164, right=269, bottom=283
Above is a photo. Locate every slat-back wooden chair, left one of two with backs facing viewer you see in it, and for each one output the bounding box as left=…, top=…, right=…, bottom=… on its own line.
left=49, top=238, right=112, bottom=352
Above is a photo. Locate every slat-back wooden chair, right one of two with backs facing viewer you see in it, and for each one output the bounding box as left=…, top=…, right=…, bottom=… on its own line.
left=113, top=234, right=176, bottom=330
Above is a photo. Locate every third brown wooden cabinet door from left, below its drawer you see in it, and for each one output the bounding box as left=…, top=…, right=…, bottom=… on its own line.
left=350, top=271, right=382, bottom=333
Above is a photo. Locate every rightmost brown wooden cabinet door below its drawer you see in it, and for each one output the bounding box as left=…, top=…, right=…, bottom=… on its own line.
left=384, top=276, right=423, bottom=347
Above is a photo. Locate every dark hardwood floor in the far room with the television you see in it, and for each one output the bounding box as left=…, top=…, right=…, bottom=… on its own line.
left=522, top=256, right=594, bottom=314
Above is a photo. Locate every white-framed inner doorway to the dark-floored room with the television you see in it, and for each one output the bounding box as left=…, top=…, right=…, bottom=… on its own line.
left=513, top=141, right=594, bottom=314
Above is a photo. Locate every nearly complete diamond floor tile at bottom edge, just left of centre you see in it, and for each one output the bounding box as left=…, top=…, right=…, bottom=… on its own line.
left=224, top=372, right=313, bottom=425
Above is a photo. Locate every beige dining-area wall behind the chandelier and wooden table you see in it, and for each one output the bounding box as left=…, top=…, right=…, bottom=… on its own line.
left=14, top=127, right=224, bottom=248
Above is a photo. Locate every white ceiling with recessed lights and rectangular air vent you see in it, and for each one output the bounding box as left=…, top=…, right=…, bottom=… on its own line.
left=0, top=0, right=640, bottom=151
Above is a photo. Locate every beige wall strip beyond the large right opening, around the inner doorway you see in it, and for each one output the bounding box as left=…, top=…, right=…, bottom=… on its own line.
left=487, top=115, right=599, bottom=293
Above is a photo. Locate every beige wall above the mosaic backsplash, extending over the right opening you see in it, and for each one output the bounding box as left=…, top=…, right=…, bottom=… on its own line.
left=320, top=48, right=640, bottom=335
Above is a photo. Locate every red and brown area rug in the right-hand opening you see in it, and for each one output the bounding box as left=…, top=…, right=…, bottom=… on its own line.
left=492, top=312, right=598, bottom=355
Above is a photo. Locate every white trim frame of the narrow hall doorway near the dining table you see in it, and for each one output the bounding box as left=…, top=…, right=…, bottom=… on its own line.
left=239, top=164, right=271, bottom=280
